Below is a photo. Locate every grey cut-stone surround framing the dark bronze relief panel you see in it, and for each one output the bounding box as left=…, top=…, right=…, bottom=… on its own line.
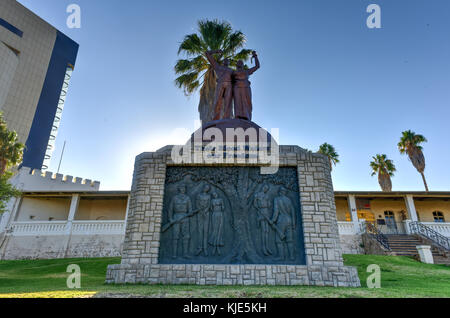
left=106, top=146, right=359, bottom=286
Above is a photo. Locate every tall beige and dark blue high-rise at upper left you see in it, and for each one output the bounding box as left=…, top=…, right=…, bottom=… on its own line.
left=0, top=0, right=78, bottom=170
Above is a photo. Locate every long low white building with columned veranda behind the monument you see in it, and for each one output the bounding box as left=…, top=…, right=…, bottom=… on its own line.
left=0, top=170, right=450, bottom=259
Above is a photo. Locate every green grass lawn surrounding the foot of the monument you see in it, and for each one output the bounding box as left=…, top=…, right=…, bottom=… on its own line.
left=0, top=255, right=450, bottom=298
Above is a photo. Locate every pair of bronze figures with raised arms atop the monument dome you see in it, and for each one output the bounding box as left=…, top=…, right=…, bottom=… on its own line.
left=205, top=50, right=260, bottom=121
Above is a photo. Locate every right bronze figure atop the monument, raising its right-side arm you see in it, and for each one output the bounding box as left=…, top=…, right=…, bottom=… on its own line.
left=233, top=51, right=260, bottom=120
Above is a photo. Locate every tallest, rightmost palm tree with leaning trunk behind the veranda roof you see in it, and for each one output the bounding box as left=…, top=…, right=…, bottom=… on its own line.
left=398, top=130, right=429, bottom=192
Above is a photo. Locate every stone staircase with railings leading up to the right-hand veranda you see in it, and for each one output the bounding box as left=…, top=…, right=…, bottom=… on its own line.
left=386, top=235, right=450, bottom=266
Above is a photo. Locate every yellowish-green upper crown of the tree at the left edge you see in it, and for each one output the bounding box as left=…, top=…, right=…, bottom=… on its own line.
left=0, top=113, right=24, bottom=175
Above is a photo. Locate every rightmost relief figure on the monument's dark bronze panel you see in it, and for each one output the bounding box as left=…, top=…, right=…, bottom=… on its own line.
left=272, top=187, right=296, bottom=260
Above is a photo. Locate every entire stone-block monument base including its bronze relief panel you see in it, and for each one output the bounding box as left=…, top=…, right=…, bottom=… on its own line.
left=106, top=146, right=360, bottom=287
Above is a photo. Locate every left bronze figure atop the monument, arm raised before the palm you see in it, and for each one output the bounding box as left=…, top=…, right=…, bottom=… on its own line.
left=205, top=50, right=233, bottom=120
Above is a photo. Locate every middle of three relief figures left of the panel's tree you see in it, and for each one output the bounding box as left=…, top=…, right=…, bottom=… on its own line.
left=196, top=185, right=211, bottom=256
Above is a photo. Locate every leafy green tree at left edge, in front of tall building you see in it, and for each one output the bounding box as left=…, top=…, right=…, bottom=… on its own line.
left=0, top=113, right=24, bottom=214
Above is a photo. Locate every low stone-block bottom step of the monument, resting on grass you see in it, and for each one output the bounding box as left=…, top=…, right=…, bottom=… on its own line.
left=106, top=264, right=360, bottom=287
